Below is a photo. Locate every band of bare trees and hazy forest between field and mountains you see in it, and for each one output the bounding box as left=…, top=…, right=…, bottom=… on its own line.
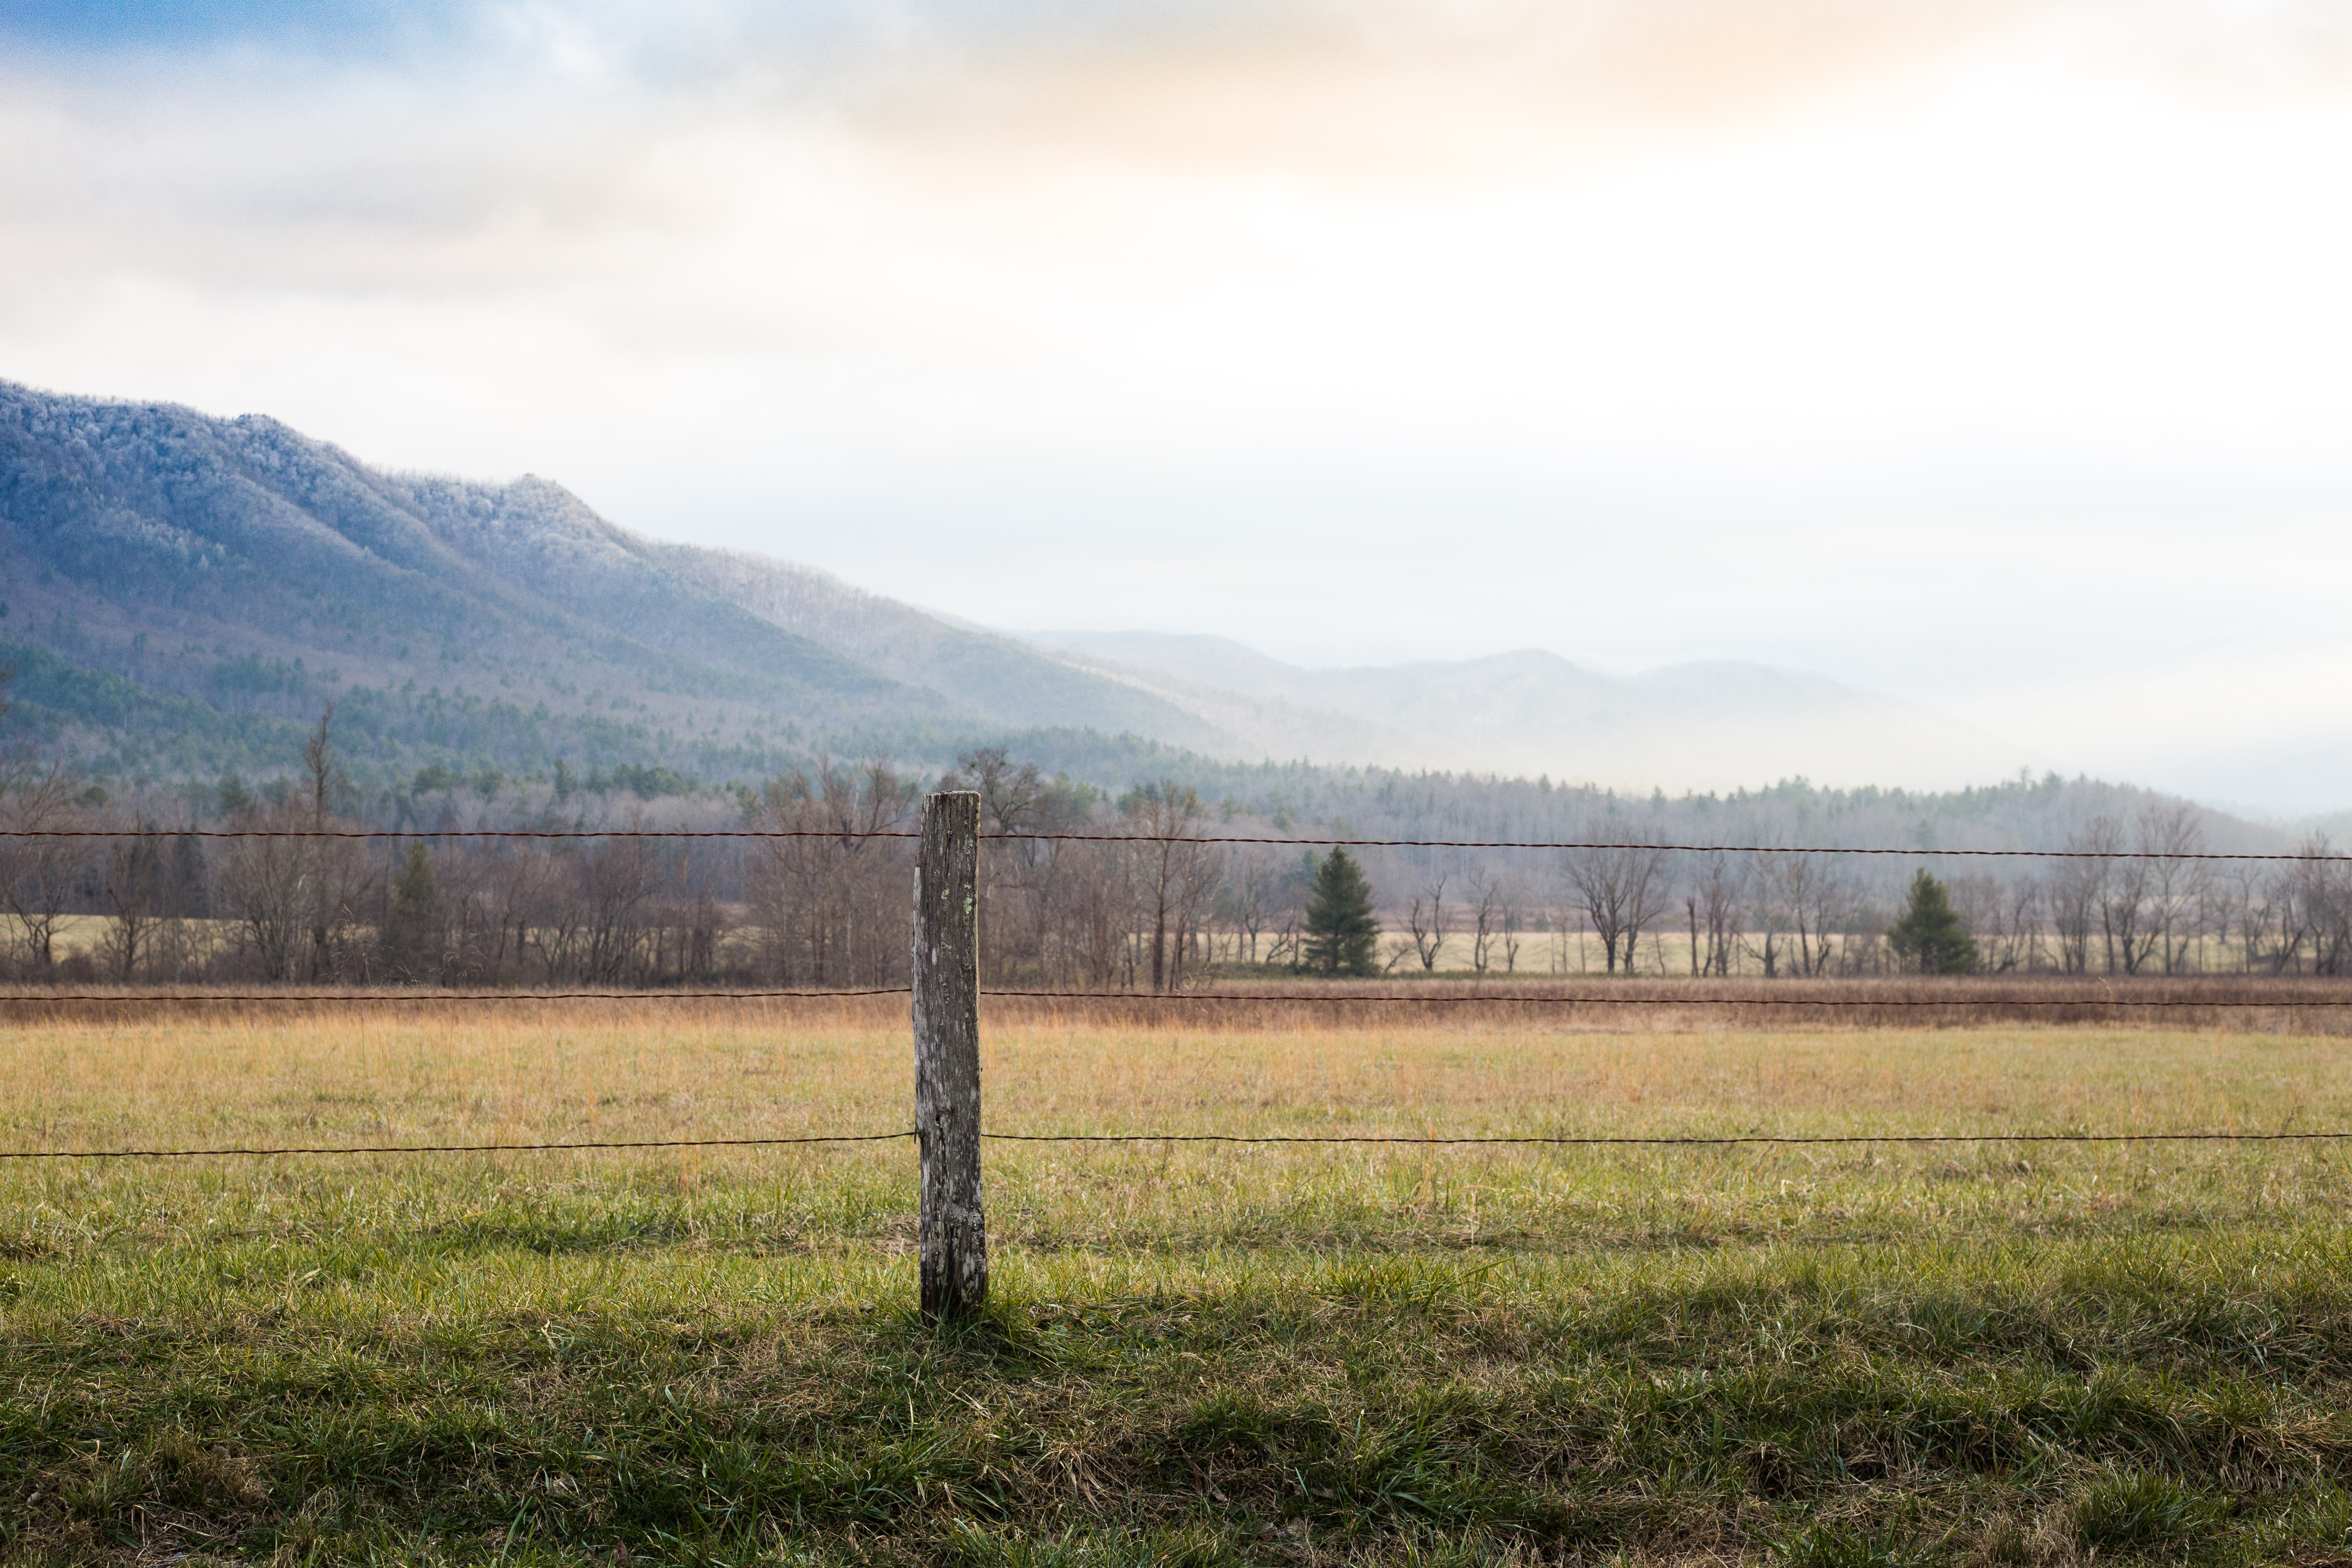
left=0, top=686, right=2352, bottom=990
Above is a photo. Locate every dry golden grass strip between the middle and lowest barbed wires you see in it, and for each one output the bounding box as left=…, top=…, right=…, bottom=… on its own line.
left=0, top=983, right=2352, bottom=1147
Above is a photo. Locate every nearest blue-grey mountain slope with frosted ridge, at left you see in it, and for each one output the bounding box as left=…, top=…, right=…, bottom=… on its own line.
left=0, top=383, right=1220, bottom=780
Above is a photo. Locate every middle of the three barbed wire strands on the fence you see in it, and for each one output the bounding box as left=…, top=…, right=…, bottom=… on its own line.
left=0, top=980, right=2352, bottom=1008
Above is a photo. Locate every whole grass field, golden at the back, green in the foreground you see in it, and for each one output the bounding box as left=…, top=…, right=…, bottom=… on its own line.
left=0, top=999, right=2352, bottom=1566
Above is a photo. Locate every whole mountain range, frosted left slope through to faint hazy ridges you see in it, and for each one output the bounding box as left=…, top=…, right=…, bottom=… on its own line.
left=0, top=383, right=2025, bottom=788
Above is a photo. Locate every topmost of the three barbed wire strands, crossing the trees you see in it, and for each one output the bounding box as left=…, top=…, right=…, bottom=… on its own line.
left=0, top=827, right=2352, bottom=863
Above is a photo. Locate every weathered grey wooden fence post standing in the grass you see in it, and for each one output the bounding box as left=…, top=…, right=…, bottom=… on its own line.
left=915, top=790, right=988, bottom=1319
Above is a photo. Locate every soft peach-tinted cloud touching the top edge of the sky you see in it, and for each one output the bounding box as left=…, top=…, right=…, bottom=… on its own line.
left=927, top=0, right=2049, bottom=161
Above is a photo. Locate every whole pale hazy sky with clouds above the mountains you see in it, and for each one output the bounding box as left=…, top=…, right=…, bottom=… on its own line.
left=0, top=0, right=2352, bottom=809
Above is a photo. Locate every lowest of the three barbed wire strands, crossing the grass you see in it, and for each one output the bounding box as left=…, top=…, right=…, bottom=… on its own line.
left=0, top=1128, right=2352, bottom=1159
